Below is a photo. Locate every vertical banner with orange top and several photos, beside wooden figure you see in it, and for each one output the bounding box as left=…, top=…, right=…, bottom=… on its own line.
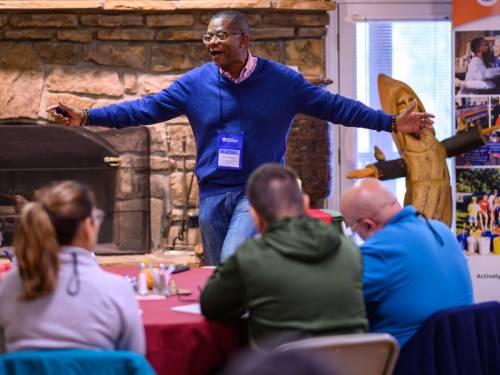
left=452, top=0, right=500, bottom=302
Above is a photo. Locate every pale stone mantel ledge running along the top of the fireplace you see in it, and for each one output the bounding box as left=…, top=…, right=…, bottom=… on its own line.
left=0, top=0, right=336, bottom=12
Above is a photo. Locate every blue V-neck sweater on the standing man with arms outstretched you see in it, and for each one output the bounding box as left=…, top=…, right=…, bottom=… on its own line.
left=90, top=58, right=391, bottom=198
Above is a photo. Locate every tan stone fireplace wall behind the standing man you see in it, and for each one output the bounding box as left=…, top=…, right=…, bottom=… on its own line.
left=0, top=0, right=334, bottom=251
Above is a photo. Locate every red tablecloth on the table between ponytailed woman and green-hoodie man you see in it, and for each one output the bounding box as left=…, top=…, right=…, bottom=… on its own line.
left=106, top=267, right=247, bottom=375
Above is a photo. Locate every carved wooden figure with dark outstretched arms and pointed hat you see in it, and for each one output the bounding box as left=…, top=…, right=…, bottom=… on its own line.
left=347, top=74, right=497, bottom=226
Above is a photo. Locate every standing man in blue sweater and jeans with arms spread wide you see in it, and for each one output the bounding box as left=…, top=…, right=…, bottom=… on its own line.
left=48, top=10, right=433, bottom=265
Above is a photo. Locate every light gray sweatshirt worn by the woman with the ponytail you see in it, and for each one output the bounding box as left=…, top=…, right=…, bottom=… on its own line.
left=0, top=247, right=145, bottom=354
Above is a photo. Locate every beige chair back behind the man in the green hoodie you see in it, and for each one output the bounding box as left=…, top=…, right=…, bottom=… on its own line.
left=276, top=333, right=399, bottom=375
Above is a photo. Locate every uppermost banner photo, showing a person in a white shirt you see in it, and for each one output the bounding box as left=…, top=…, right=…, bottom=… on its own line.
left=455, top=30, right=500, bottom=95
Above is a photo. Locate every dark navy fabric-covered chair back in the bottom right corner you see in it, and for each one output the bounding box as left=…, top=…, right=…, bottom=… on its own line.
left=394, top=302, right=500, bottom=375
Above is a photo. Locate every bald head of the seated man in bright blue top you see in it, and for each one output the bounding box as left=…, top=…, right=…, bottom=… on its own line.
left=340, top=178, right=401, bottom=239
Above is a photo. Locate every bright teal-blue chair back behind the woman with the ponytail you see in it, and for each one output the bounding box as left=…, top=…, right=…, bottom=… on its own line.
left=0, top=349, right=155, bottom=375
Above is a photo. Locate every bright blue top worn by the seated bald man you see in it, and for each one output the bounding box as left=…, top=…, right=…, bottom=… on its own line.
left=361, top=206, right=473, bottom=346
